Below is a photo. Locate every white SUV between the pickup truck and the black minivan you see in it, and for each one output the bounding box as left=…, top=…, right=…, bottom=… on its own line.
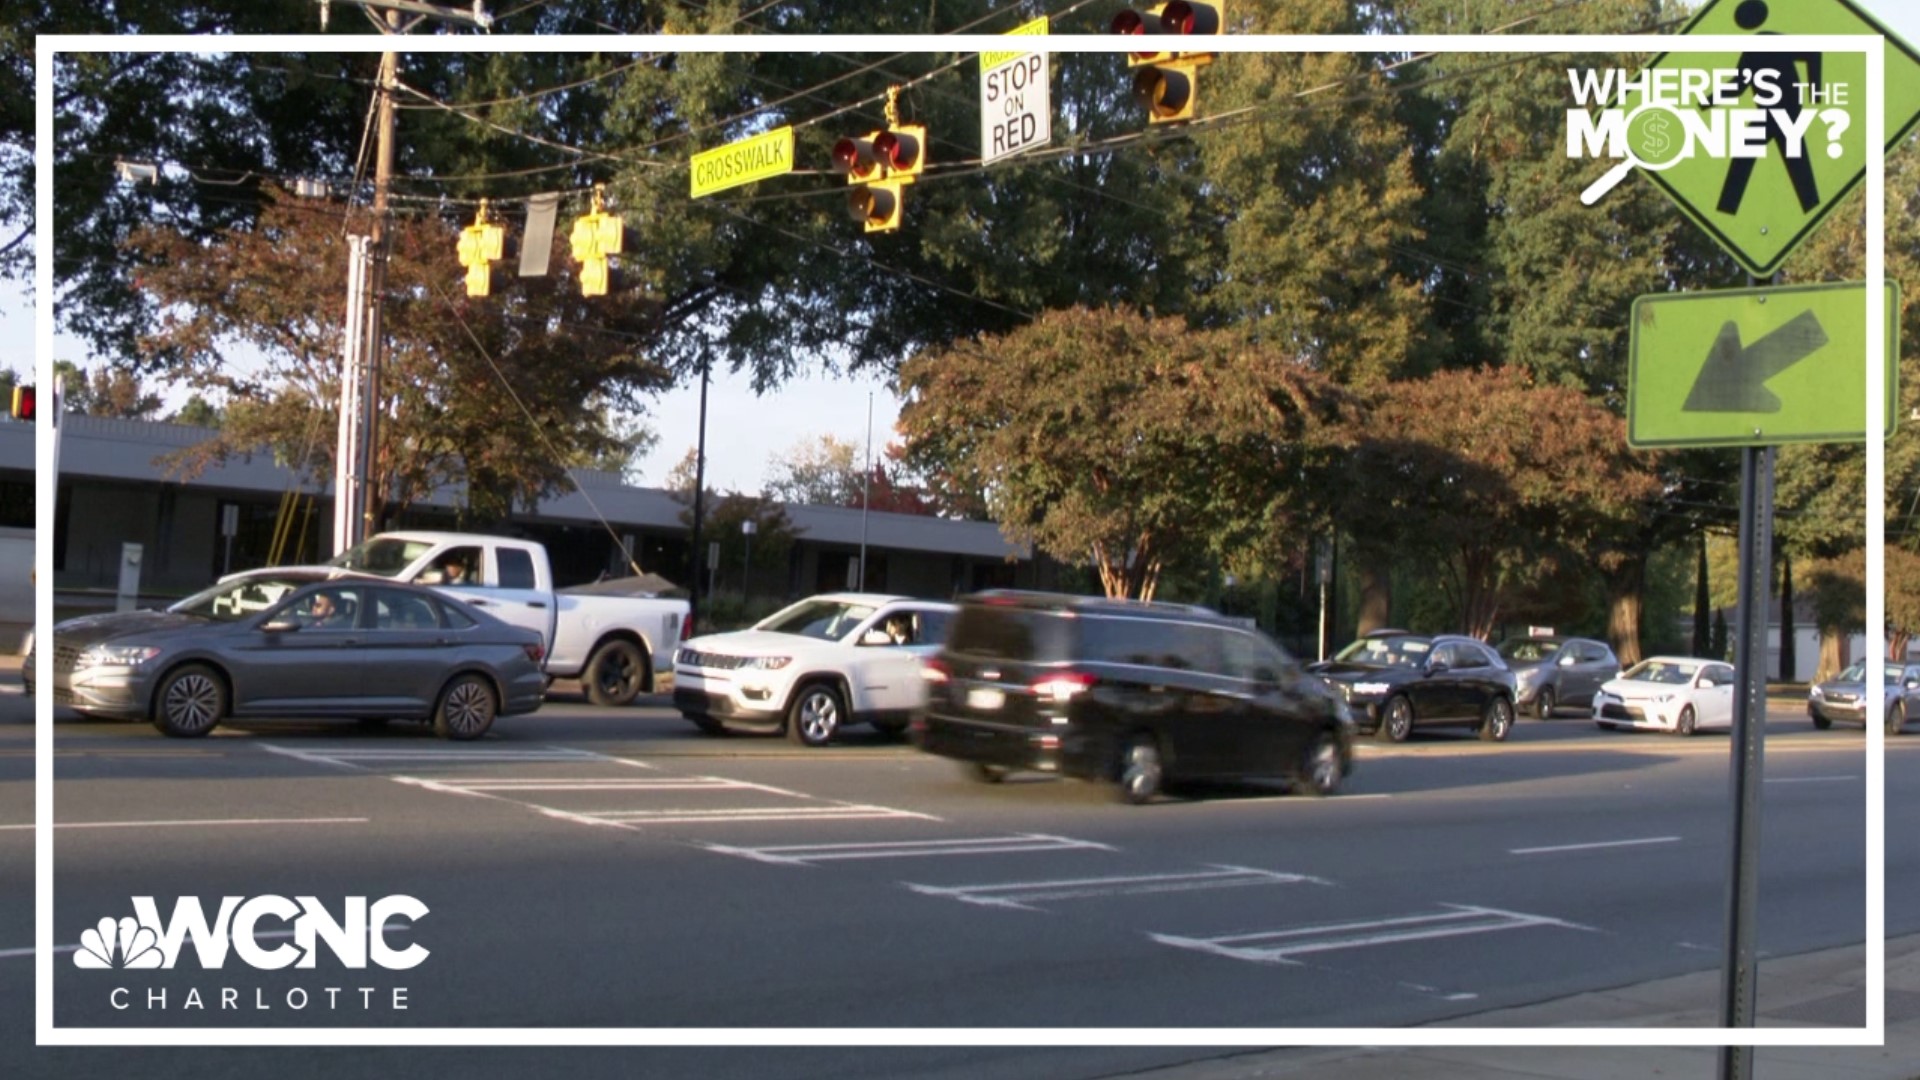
left=674, top=592, right=958, bottom=746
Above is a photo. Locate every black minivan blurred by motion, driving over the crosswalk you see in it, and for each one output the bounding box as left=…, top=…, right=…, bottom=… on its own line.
left=912, top=590, right=1354, bottom=803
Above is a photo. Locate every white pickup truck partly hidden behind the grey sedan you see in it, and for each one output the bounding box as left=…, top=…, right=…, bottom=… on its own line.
left=326, top=532, right=689, bottom=705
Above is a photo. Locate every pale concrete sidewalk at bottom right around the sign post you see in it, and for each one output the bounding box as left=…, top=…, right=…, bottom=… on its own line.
left=1131, top=934, right=1920, bottom=1080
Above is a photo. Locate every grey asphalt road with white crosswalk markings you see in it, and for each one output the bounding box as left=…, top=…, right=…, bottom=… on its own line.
left=0, top=684, right=1920, bottom=1078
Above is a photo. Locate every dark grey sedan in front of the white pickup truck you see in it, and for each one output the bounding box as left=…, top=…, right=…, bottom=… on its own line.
left=42, top=571, right=545, bottom=738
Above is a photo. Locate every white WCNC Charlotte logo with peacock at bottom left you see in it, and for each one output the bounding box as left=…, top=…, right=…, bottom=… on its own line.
left=73, top=896, right=430, bottom=1011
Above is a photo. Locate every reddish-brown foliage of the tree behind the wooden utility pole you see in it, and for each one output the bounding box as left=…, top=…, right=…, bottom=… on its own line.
left=129, top=189, right=668, bottom=521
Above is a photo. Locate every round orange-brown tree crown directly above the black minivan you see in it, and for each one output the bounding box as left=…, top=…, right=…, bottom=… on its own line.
left=900, top=309, right=1334, bottom=600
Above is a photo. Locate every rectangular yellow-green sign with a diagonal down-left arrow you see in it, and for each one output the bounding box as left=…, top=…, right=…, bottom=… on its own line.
left=1626, top=281, right=1901, bottom=450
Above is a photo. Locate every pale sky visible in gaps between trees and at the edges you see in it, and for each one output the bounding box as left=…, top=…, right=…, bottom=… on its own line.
left=0, top=0, right=1920, bottom=492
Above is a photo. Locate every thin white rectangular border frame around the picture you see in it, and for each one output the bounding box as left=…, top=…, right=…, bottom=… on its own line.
left=35, top=35, right=1887, bottom=1047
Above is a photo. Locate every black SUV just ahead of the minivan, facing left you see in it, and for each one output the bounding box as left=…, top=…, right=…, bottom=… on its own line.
left=1311, top=630, right=1519, bottom=742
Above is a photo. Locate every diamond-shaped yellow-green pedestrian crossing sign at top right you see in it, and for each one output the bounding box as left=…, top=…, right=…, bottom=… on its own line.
left=1622, top=0, right=1920, bottom=277
